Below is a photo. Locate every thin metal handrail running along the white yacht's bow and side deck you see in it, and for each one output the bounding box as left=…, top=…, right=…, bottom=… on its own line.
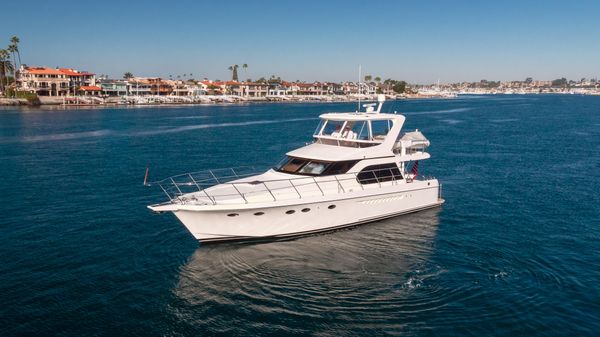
left=148, top=167, right=434, bottom=205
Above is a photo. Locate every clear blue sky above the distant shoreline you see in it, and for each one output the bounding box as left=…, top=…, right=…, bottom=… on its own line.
left=0, top=0, right=600, bottom=83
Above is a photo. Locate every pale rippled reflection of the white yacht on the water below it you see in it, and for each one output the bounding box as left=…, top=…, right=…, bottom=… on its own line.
left=171, top=209, right=439, bottom=332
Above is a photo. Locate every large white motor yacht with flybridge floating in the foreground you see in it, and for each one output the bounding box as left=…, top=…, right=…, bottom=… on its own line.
left=148, top=96, right=444, bottom=242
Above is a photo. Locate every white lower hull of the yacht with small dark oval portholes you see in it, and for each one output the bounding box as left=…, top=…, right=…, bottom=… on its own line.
left=166, top=179, right=443, bottom=242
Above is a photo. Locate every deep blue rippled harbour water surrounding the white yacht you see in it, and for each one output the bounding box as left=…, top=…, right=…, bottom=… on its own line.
left=0, top=95, right=600, bottom=336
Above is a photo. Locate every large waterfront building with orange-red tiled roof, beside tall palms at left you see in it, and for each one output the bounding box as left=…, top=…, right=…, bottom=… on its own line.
left=17, top=65, right=96, bottom=96
